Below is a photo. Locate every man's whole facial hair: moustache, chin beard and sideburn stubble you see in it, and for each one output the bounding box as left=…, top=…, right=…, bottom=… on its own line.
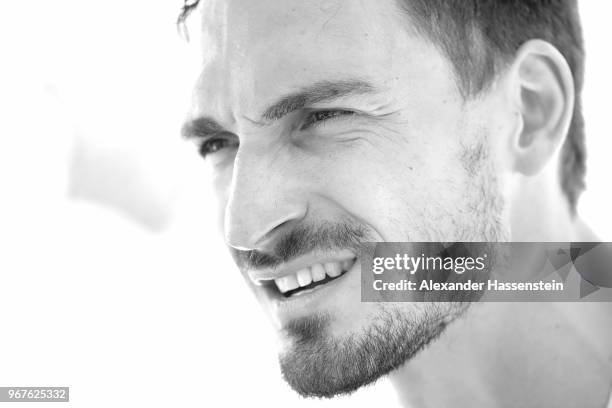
left=234, top=134, right=509, bottom=398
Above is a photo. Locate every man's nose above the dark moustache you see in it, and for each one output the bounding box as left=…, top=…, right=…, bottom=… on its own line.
left=224, top=146, right=308, bottom=251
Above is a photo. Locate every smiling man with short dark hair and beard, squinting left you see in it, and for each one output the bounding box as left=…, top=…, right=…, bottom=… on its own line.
left=181, top=0, right=612, bottom=407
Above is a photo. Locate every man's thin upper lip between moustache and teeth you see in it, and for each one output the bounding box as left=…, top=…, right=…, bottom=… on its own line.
left=247, top=250, right=357, bottom=284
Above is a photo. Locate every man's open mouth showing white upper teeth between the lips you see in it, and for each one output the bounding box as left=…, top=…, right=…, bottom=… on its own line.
left=263, top=258, right=357, bottom=298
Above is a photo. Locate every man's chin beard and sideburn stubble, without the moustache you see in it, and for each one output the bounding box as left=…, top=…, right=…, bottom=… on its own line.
left=279, top=138, right=509, bottom=398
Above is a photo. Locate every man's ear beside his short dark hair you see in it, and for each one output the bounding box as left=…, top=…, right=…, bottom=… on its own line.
left=507, top=40, right=574, bottom=176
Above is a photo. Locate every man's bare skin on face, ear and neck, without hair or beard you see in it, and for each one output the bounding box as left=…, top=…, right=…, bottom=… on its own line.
left=188, top=0, right=612, bottom=406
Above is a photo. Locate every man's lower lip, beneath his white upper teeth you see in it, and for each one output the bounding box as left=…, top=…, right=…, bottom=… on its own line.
left=269, top=259, right=360, bottom=319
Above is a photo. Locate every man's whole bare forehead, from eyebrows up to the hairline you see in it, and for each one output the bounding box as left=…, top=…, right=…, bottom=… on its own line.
left=192, top=0, right=454, bottom=125
